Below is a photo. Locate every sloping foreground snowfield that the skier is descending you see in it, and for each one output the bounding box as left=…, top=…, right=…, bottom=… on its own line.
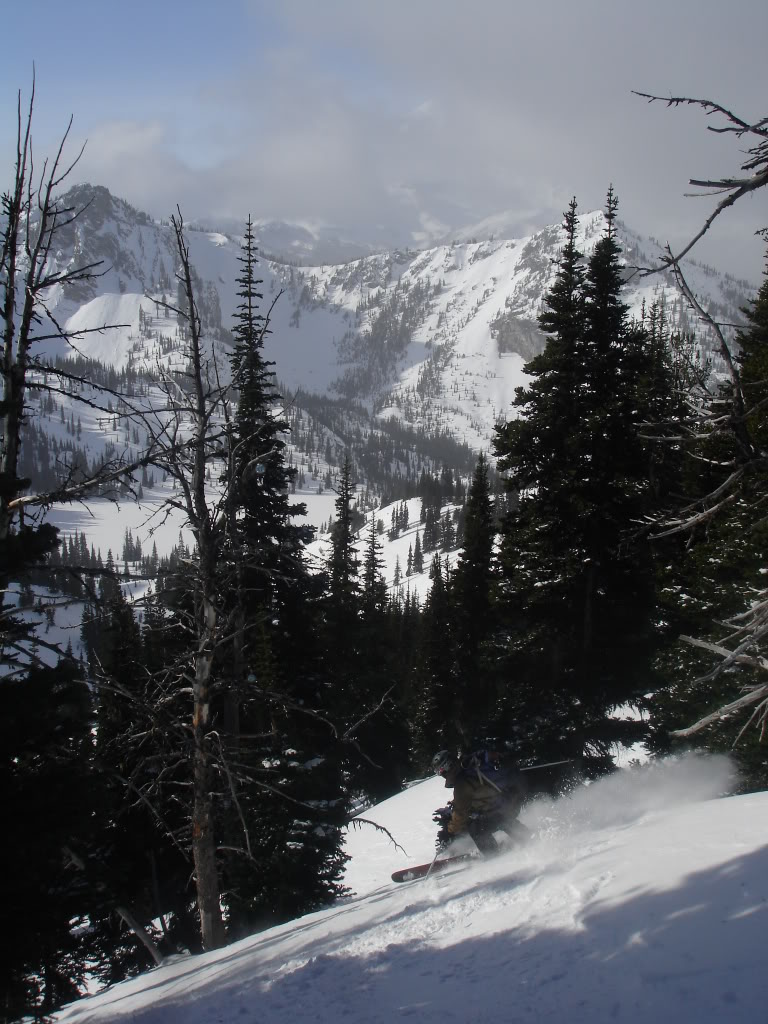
left=56, top=757, right=768, bottom=1024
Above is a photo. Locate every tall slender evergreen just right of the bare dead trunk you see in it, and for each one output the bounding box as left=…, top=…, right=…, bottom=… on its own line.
left=218, top=218, right=346, bottom=935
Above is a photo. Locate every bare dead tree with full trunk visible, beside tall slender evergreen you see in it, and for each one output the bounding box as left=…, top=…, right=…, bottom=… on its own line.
left=119, top=209, right=301, bottom=949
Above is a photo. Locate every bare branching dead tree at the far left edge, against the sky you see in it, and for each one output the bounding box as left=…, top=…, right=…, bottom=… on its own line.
left=0, top=75, right=145, bottom=679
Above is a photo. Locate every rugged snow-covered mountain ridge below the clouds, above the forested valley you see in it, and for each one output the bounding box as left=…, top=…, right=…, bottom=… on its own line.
left=39, top=185, right=753, bottom=451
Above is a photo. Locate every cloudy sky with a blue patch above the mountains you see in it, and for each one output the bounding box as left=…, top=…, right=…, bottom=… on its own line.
left=0, top=0, right=768, bottom=281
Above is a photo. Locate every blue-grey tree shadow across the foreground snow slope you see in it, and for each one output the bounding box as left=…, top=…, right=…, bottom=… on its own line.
left=63, top=847, right=768, bottom=1024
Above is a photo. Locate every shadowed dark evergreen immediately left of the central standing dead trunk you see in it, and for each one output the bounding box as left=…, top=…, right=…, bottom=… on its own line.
left=81, top=593, right=200, bottom=984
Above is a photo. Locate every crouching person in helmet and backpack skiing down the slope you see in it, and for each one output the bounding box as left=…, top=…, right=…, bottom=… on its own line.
left=432, top=751, right=529, bottom=853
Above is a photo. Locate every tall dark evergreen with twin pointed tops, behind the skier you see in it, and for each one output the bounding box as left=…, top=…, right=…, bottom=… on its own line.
left=494, top=190, right=671, bottom=772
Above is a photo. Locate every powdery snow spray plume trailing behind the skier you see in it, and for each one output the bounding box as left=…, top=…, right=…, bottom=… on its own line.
left=523, top=754, right=736, bottom=838
